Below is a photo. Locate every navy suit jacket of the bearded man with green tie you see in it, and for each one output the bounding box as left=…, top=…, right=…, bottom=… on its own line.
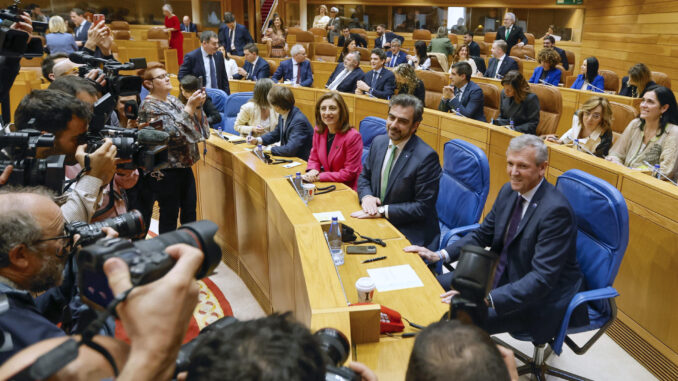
left=358, top=135, right=441, bottom=250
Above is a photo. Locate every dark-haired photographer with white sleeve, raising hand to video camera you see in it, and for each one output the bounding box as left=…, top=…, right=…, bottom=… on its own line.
left=14, top=90, right=117, bottom=222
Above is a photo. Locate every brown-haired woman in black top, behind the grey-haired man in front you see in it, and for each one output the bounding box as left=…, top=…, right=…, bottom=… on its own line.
left=493, top=70, right=539, bottom=135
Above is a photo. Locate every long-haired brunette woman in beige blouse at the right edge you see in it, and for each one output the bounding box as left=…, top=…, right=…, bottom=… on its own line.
left=606, top=86, right=678, bottom=178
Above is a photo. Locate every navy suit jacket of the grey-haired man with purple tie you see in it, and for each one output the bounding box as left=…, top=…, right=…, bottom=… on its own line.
left=446, top=180, right=587, bottom=343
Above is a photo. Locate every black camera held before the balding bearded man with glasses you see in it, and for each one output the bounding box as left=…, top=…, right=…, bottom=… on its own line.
left=65, top=209, right=146, bottom=246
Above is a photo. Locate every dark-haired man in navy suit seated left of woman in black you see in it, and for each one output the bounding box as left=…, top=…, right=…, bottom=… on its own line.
left=438, top=62, right=485, bottom=122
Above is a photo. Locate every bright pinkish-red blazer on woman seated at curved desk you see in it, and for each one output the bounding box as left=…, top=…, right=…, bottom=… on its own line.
left=306, top=128, right=363, bottom=190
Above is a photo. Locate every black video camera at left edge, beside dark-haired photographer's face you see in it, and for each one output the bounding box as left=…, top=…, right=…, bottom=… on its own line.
left=0, top=129, right=66, bottom=194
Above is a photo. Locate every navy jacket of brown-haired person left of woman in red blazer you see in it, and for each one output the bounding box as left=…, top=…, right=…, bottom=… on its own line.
left=261, top=106, right=313, bottom=160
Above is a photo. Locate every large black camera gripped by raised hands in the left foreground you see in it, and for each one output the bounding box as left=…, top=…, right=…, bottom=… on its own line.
left=77, top=220, right=221, bottom=309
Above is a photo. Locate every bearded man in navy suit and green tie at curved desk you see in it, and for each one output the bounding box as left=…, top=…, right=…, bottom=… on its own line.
left=351, top=94, right=441, bottom=250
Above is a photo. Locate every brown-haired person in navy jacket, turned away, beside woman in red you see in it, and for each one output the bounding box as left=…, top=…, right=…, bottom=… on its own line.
left=247, top=86, right=313, bottom=160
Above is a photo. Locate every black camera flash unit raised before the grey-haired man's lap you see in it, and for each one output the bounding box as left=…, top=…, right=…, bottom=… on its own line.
left=443, top=245, right=499, bottom=327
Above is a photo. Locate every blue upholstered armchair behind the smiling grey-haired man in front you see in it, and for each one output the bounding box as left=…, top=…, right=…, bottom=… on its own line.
left=504, top=169, right=629, bottom=380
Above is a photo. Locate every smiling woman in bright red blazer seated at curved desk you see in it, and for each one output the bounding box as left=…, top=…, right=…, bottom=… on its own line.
left=302, top=91, right=363, bottom=189
